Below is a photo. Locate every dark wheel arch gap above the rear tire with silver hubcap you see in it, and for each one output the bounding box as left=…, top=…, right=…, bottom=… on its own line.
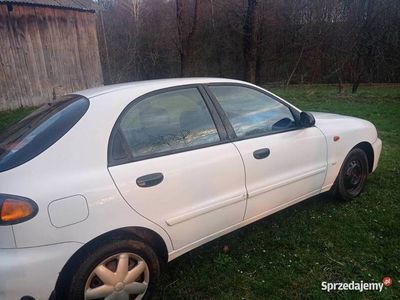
left=54, top=226, right=168, bottom=299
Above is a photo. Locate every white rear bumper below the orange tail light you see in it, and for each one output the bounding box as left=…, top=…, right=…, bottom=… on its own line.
left=0, top=242, right=82, bottom=300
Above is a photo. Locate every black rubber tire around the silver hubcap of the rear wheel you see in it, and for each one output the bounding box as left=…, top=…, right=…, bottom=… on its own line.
left=56, top=239, right=160, bottom=300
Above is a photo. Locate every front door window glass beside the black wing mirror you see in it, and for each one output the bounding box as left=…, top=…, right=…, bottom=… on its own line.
left=209, top=85, right=296, bottom=138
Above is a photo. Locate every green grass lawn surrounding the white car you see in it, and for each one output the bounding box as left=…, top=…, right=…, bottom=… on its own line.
left=0, top=85, right=400, bottom=299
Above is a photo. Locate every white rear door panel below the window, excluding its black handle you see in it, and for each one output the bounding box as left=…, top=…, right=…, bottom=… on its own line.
left=109, top=143, right=246, bottom=249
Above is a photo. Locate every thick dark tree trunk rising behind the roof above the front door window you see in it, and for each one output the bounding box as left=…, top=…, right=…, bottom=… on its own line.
left=243, top=0, right=257, bottom=83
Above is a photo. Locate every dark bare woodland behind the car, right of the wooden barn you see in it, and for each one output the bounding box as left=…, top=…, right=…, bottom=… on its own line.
left=97, top=0, right=400, bottom=85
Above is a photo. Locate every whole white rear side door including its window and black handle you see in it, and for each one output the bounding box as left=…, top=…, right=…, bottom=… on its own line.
left=109, top=86, right=246, bottom=249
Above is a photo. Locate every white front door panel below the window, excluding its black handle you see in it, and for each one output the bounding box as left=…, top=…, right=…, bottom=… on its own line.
left=234, top=127, right=327, bottom=219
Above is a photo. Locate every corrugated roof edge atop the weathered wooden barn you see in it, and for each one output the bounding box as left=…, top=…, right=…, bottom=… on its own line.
left=0, top=0, right=96, bottom=12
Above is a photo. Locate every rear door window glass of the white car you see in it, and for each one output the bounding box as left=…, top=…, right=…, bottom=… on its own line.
left=113, top=88, right=220, bottom=158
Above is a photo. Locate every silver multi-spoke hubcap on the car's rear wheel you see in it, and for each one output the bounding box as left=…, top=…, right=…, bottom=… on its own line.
left=85, top=253, right=150, bottom=300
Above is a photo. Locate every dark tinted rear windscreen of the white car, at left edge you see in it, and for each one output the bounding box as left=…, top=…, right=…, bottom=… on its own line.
left=0, top=95, right=89, bottom=172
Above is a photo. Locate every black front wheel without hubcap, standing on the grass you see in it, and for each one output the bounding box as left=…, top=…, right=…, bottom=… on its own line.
left=333, top=148, right=369, bottom=201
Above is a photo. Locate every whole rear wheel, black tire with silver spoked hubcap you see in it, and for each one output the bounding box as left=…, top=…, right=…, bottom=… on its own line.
left=66, top=240, right=160, bottom=300
